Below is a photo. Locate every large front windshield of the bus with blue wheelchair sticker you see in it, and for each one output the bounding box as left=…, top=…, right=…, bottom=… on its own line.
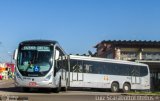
left=17, top=46, right=53, bottom=77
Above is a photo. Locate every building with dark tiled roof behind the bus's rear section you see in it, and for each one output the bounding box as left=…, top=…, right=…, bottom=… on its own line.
left=95, top=40, right=160, bottom=90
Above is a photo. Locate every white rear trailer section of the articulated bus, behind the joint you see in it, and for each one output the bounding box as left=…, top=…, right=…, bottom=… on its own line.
left=70, top=55, right=150, bottom=92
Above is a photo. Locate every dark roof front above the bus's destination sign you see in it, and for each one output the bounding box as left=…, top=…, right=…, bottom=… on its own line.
left=20, top=40, right=58, bottom=45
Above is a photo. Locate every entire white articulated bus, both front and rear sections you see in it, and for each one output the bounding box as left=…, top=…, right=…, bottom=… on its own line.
left=14, top=40, right=150, bottom=92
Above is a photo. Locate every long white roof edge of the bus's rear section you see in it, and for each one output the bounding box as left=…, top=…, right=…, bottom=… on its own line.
left=69, top=55, right=148, bottom=66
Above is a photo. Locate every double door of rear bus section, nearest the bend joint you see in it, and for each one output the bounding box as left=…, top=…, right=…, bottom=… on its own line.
left=71, top=60, right=83, bottom=81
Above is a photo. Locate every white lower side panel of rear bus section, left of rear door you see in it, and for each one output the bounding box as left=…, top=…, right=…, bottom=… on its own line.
left=70, top=73, right=130, bottom=89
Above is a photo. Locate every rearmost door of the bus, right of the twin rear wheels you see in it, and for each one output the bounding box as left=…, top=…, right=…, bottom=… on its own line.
left=131, top=67, right=141, bottom=84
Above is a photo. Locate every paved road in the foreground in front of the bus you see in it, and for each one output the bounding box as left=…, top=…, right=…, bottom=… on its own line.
left=0, top=80, right=160, bottom=101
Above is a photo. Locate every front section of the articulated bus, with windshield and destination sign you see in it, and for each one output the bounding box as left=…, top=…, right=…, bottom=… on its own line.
left=14, top=40, right=69, bottom=92
